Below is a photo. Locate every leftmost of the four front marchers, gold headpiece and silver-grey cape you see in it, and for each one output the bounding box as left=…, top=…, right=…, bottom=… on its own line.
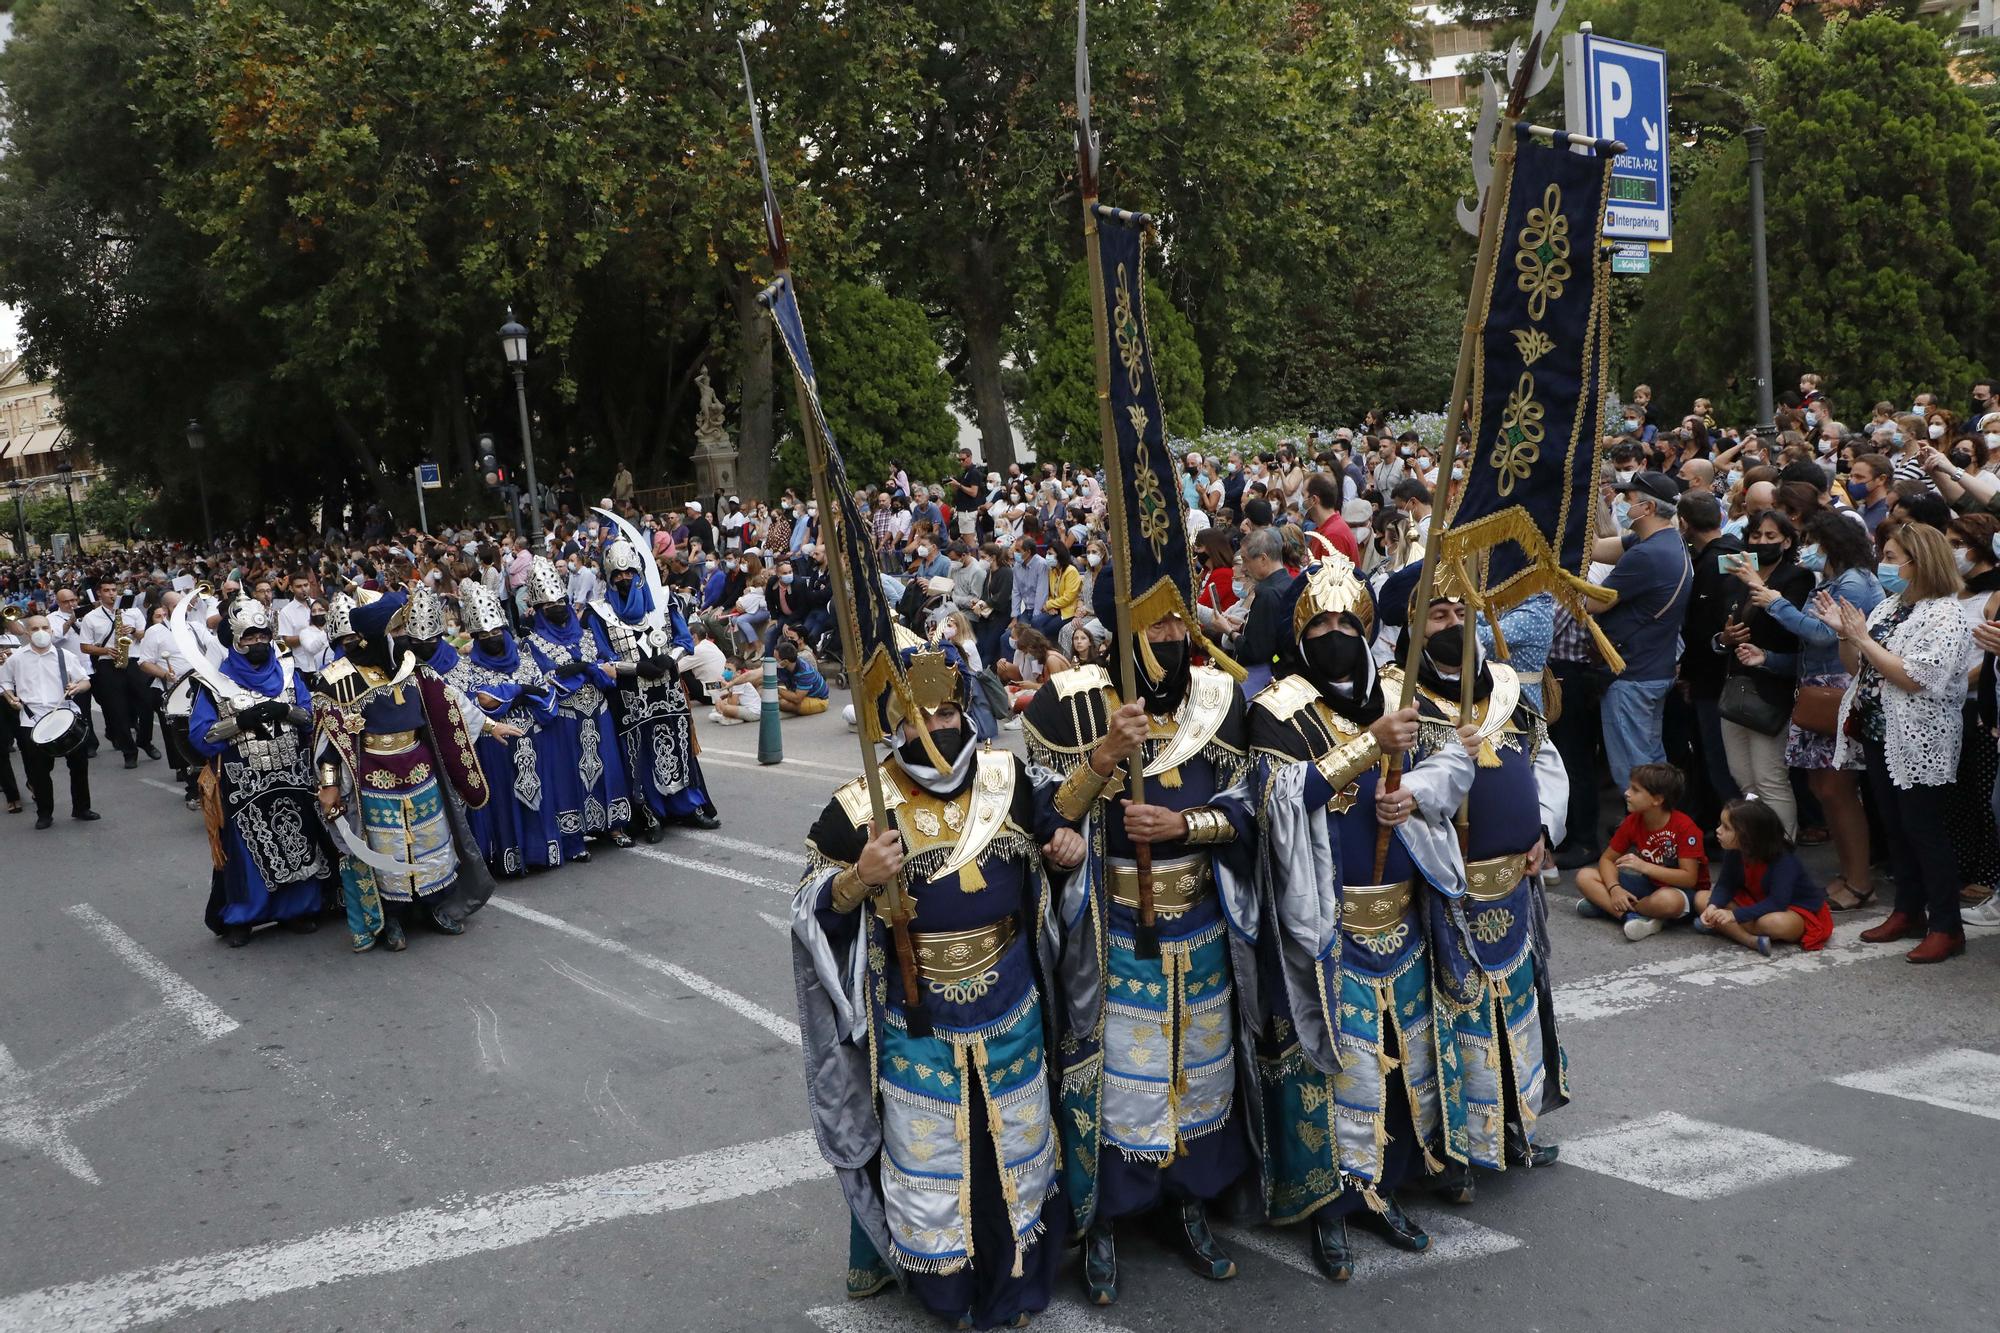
left=792, top=646, right=1082, bottom=1329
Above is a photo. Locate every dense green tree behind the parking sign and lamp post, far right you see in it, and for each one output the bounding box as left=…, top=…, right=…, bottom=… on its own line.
left=1632, top=16, right=2000, bottom=420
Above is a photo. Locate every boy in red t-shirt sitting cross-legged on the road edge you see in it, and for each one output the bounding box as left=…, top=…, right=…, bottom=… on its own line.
left=1576, top=765, right=1708, bottom=941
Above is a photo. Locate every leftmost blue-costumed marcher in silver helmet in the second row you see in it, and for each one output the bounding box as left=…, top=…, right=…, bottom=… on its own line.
left=184, top=598, right=334, bottom=949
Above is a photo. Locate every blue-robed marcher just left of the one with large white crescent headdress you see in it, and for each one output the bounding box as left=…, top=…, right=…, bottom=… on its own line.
left=526, top=556, right=632, bottom=844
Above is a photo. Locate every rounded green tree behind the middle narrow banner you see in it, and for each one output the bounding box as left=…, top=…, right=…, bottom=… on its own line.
left=1022, top=262, right=1202, bottom=464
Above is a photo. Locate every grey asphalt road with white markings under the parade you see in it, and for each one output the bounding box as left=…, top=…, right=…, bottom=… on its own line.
left=0, top=715, right=2000, bottom=1333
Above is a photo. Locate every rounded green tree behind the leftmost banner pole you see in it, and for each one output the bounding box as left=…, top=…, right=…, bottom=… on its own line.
left=778, top=282, right=958, bottom=490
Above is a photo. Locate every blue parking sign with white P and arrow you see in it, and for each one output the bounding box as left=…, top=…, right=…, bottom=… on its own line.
left=1562, top=32, right=1674, bottom=240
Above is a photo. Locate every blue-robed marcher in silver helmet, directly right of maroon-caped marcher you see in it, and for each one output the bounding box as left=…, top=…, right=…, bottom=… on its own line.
left=446, top=578, right=562, bottom=875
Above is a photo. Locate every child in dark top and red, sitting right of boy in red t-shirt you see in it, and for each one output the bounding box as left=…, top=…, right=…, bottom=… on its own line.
left=1694, top=801, right=1834, bottom=957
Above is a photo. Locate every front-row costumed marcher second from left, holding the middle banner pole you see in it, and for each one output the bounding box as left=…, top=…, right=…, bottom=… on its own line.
left=1024, top=576, right=1256, bottom=1305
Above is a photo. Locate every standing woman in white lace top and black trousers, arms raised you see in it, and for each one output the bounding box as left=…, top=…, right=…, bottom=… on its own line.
left=1814, top=522, right=1972, bottom=963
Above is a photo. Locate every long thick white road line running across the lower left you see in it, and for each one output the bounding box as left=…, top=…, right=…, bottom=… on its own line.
left=0, top=1131, right=832, bottom=1333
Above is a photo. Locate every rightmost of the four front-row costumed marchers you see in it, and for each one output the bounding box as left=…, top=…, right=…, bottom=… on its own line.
left=1382, top=562, right=1570, bottom=1203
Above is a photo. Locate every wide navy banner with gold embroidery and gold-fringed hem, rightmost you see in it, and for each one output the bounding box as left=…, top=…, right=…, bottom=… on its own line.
left=1440, top=130, right=1612, bottom=614
